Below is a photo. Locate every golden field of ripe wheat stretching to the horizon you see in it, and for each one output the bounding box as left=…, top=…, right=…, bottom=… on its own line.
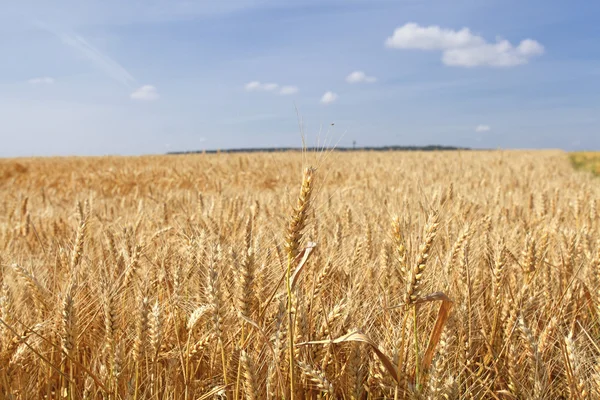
left=0, top=151, right=600, bottom=400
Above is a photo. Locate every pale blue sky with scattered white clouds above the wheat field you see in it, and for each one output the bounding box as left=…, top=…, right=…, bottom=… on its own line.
left=0, top=0, right=600, bottom=157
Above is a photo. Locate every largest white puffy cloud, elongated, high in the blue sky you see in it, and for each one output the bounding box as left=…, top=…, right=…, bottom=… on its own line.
left=385, top=22, right=544, bottom=68
